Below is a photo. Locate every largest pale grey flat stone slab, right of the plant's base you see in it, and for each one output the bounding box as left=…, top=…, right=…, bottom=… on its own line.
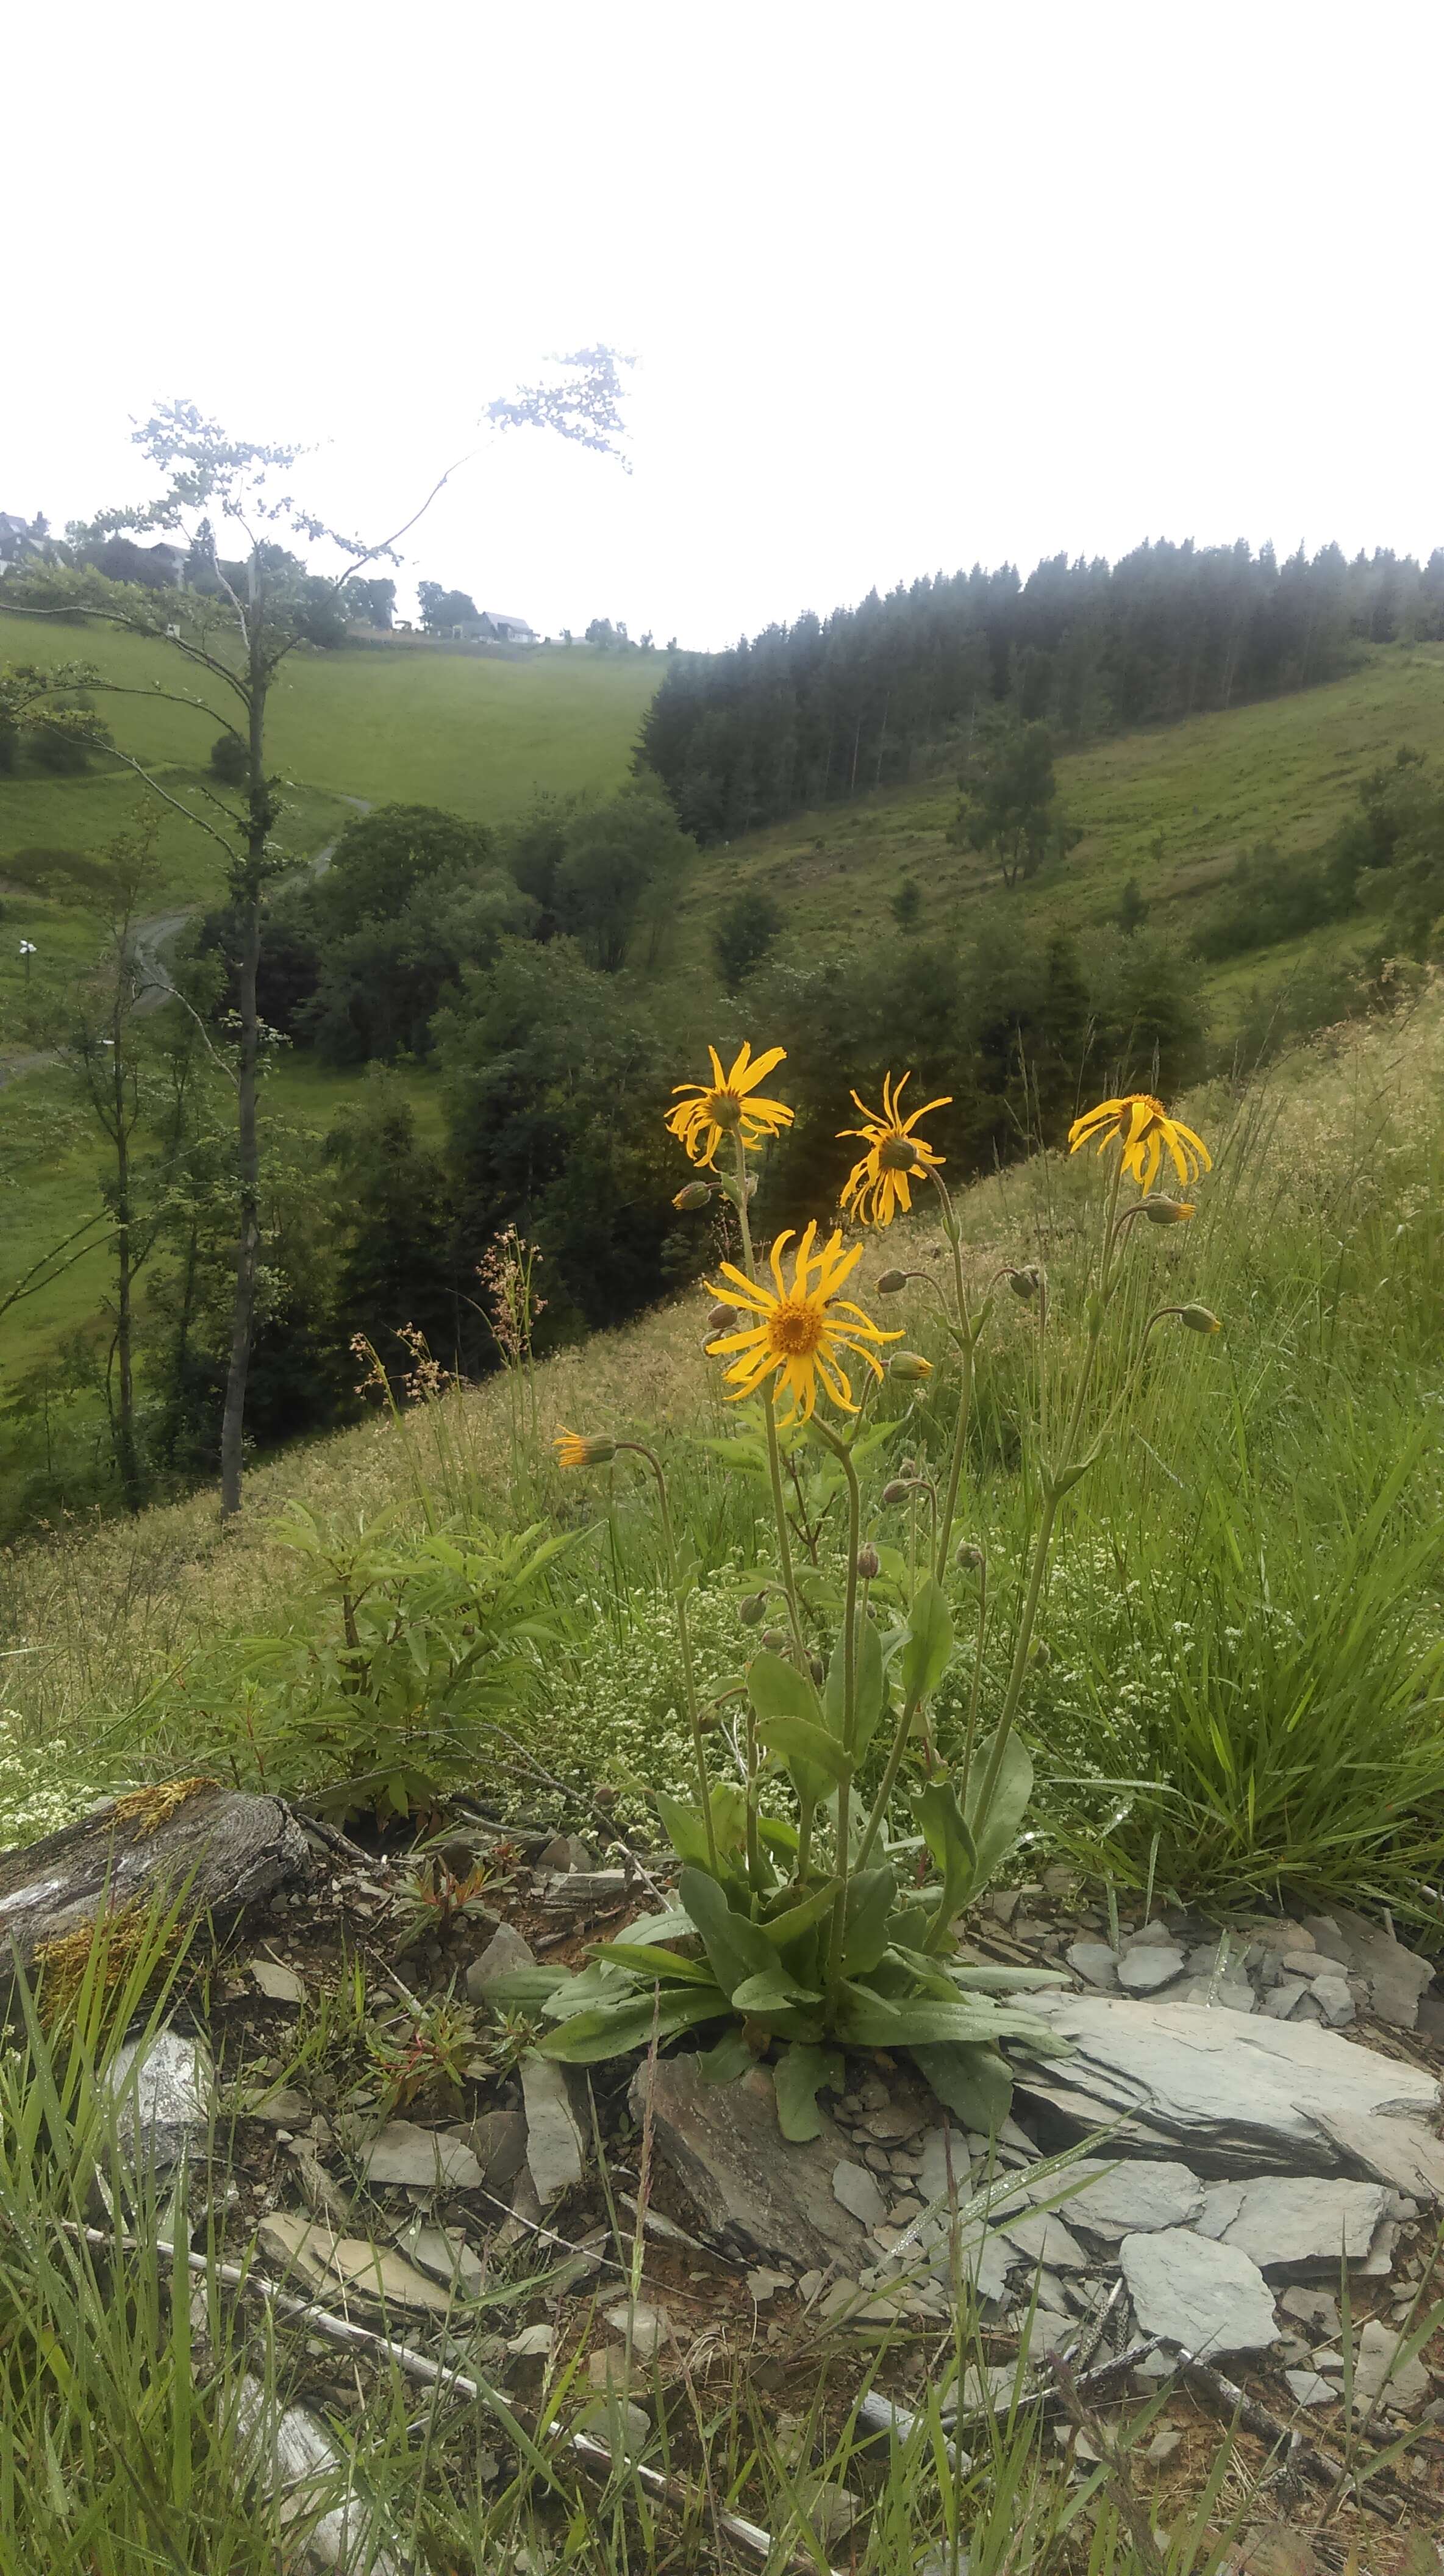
left=1012, top=1991, right=1439, bottom=2187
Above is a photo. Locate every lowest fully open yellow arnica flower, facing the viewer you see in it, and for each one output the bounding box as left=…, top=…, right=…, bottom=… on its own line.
left=702, top=1226, right=901, bottom=1422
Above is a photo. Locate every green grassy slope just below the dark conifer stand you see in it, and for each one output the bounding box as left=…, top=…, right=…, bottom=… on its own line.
left=682, top=644, right=1444, bottom=1025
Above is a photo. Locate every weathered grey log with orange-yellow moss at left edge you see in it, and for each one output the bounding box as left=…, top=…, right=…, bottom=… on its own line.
left=0, top=1780, right=309, bottom=1983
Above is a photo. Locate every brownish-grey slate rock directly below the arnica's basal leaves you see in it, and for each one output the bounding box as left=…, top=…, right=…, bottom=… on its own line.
left=628, top=2058, right=867, bottom=2272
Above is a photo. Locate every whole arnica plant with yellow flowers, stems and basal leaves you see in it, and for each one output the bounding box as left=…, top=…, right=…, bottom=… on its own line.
left=494, top=1046, right=1218, bottom=2138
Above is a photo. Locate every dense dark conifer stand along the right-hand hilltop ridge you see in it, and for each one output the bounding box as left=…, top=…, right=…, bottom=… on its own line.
left=641, top=541, right=1444, bottom=842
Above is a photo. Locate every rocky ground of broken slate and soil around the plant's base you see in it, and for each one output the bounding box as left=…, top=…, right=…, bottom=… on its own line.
left=0, top=1819, right=1444, bottom=2576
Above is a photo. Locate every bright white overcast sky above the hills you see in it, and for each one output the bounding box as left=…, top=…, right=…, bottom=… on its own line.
left=0, top=0, right=1444, bottom=644
